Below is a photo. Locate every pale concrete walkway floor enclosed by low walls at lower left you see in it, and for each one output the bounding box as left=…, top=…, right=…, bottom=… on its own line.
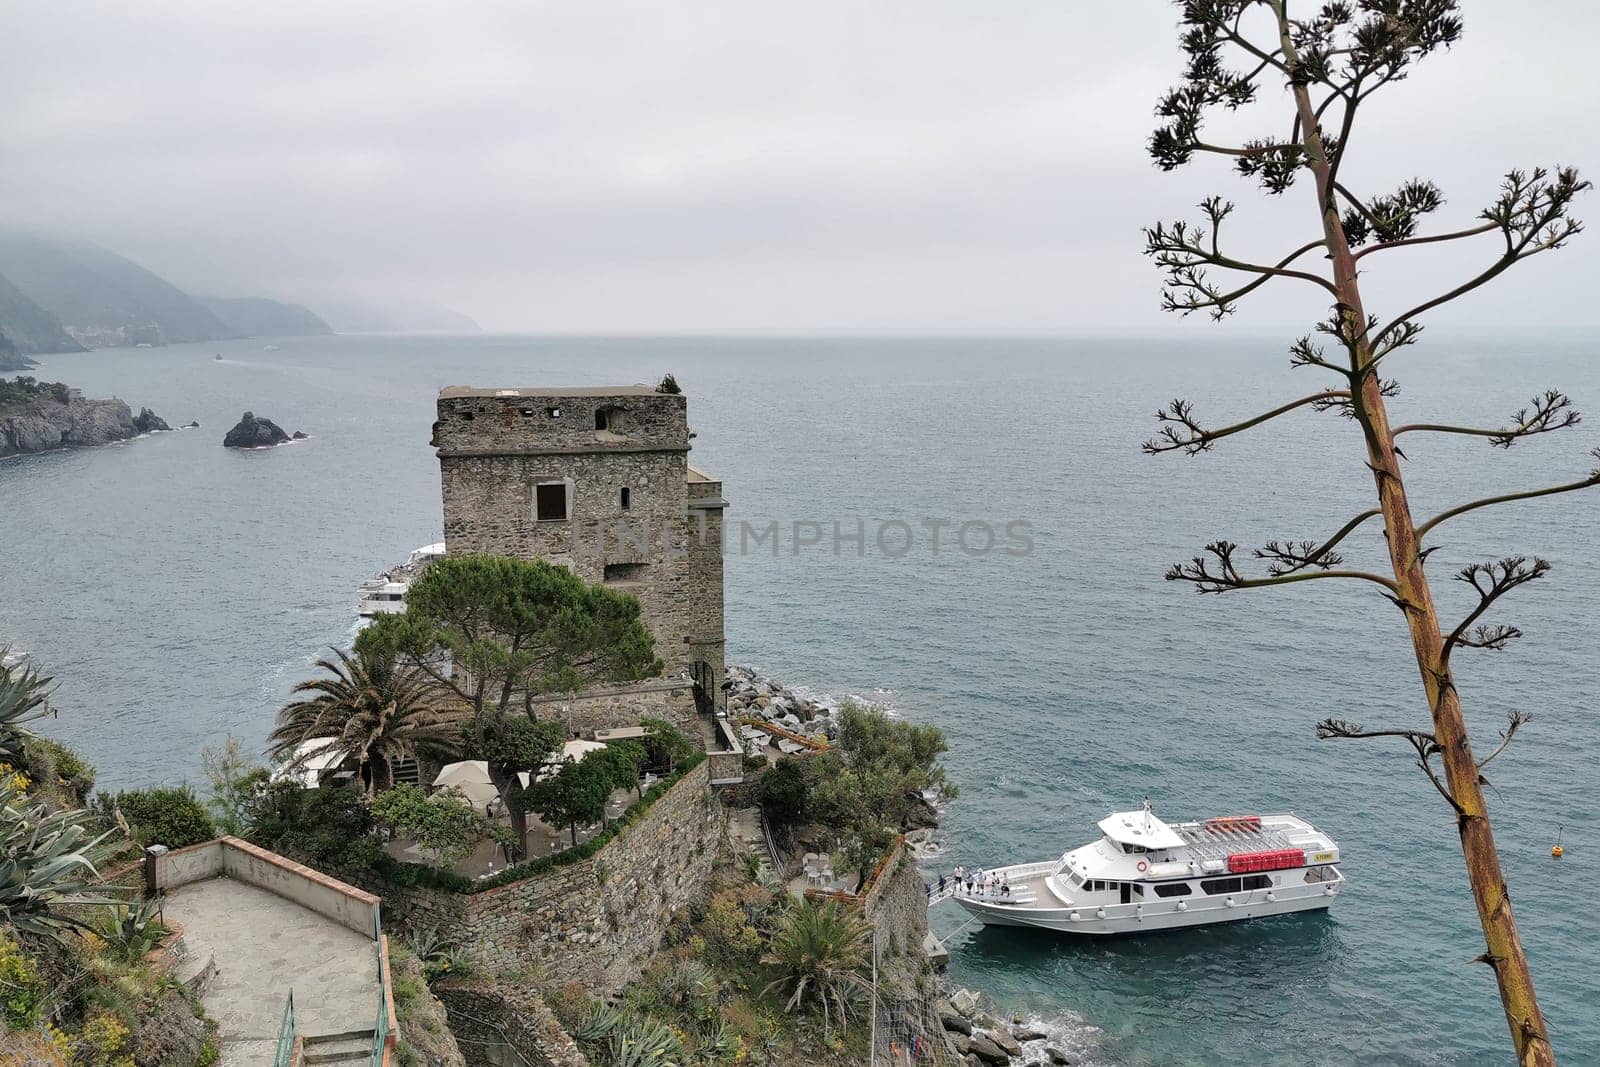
left=162, top=878, right=379, bottom=1067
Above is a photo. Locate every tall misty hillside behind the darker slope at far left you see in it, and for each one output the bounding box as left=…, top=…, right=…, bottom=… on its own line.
left=0, top=229, right=240, bottom=346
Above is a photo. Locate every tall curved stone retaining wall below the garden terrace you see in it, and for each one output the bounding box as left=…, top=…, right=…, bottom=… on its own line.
left=362, top=763, right=725, bottom=993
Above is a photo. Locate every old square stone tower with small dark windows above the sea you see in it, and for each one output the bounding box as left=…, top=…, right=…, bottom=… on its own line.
left=434, top=386, right=726, bottom=710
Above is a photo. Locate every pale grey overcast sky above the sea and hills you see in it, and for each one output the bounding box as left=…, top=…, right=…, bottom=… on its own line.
left=0, top=0, right=1600, bottom=331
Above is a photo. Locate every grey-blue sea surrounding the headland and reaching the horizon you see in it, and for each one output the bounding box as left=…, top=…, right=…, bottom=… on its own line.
left=0, top=326, right=1600, bottom=1064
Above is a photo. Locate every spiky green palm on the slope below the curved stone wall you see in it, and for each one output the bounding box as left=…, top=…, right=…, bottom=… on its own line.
left=762, top=901, right=869, bottom=1033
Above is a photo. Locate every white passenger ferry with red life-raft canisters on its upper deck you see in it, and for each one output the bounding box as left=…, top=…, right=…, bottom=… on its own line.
left=946, top=801, right=1344, bottom=934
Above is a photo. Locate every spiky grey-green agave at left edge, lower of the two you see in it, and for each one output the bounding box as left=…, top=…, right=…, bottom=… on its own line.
left=0, top=779, right=118, bottom=939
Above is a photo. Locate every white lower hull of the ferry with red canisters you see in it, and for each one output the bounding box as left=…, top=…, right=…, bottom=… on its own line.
left=954, top=885, right=1339, bottom=936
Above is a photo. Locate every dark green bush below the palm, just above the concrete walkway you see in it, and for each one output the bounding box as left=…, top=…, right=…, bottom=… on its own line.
left=246, top=782, right=382, bottom=881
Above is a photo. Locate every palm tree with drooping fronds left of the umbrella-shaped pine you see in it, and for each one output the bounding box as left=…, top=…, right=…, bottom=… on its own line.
left=267, top=648, right=462, bottom=793
